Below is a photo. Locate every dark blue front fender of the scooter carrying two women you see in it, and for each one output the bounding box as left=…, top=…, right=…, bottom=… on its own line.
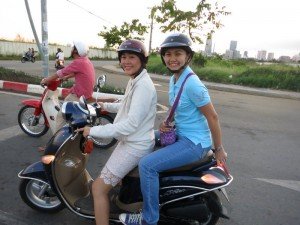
left=18, top=161, right=49, bottom=183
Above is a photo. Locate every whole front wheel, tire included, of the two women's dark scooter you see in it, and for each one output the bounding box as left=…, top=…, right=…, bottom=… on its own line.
left=19, top=179, right=65, bottom=213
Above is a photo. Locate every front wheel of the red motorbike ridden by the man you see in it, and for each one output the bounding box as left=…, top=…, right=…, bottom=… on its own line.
left=18, top=105, right=49, bottom=137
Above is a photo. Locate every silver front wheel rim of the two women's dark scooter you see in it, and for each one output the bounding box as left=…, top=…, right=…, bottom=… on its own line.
left=26, top=180, right=61, bottom=209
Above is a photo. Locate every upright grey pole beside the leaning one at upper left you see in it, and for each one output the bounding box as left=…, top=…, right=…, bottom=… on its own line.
left=41, top=0, right=49, bottom=77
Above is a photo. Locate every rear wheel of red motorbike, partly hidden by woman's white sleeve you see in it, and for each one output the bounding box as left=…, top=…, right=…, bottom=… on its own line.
left=94, top=115, right=118, bottom=149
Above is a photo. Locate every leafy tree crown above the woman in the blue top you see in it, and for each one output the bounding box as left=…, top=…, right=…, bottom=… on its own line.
left=152, top=0, right=230, bottom=44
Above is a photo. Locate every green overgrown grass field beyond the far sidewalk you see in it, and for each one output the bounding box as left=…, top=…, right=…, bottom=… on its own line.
left=147, top=54, right=300, bottom=92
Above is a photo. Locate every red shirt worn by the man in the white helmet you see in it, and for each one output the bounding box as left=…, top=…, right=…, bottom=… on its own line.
left=56, top=57, right=95, bottom=99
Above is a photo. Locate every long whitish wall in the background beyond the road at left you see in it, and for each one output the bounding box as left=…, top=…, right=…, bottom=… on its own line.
left=0, top=41, right=118, bottom=59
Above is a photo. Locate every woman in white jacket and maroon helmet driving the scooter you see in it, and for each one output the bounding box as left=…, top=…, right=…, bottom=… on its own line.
left=77, top=40, right=157, bottom=225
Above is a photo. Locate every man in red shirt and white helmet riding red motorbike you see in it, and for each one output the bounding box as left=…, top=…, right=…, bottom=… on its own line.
left=41, top=41, right=95, bottom=131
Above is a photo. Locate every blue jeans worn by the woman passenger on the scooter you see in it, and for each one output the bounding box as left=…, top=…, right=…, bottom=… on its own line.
left=139, top=137, right=210, bottom=225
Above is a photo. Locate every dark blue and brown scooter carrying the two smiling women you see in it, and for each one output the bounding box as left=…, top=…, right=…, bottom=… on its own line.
left=18, top=98, right=233, bottom=225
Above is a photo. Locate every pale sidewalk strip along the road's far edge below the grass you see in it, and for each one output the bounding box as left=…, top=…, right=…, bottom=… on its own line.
left=95, top=65, right=300, bottom=100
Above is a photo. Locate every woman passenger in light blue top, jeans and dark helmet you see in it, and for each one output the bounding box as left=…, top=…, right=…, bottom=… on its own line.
left=120, top=34, right=227, bottom=225
